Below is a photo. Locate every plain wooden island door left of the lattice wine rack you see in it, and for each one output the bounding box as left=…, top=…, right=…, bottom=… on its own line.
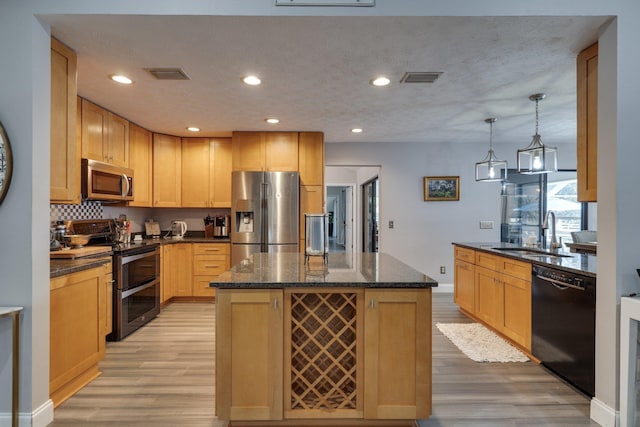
left=216, top=289, right=283, bottom=420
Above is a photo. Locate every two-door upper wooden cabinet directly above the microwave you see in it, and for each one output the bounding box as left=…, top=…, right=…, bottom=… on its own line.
left=82, top=99, right=129, bottom=167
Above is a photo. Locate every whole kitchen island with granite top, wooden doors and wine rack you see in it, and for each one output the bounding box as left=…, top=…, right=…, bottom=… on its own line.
left=210, top=253, right=437, bottom=426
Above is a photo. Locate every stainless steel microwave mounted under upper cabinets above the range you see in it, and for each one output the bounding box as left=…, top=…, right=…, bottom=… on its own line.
left=82, top=159, right=133, bottom=201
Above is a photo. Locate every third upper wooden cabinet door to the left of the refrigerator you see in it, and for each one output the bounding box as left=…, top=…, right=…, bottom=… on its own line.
left=153, top=133, right=182, bottom=208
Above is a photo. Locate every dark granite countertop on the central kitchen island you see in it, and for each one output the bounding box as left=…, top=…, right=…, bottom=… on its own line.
left=209, top=253, right=438, bottom=289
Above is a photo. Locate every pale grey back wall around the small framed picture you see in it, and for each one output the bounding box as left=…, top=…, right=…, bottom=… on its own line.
left=325, top=141, right=576, bottom=284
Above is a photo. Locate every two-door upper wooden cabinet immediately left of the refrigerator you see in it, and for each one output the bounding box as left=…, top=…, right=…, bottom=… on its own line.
left=182, top=138, right=231, bottom=208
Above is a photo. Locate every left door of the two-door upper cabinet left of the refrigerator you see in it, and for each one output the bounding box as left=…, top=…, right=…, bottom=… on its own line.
left=181, top=138, right=210, bottom=208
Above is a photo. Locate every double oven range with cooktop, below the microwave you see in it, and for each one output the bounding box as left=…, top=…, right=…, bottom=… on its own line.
left=67, top=219, right=160, bottom=341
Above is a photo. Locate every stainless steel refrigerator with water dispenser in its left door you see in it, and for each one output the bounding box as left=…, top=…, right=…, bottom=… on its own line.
left=231, top=171, right=300, bottom=265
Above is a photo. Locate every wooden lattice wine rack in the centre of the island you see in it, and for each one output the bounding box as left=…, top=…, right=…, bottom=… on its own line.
left=285, top=291, right=362, bottom=416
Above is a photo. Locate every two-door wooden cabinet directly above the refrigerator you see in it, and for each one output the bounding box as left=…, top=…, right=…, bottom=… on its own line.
left=232, top=132, right=298, bottom=172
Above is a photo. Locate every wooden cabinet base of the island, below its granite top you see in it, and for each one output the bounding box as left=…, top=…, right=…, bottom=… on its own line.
left=216, top=288, right=431, bottom=425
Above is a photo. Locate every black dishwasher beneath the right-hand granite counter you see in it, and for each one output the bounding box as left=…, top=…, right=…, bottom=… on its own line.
left=531, top=265, right=596, bottom=397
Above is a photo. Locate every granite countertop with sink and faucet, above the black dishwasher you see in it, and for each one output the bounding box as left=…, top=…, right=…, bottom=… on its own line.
left=453, top=242, right=597, bottom=277
